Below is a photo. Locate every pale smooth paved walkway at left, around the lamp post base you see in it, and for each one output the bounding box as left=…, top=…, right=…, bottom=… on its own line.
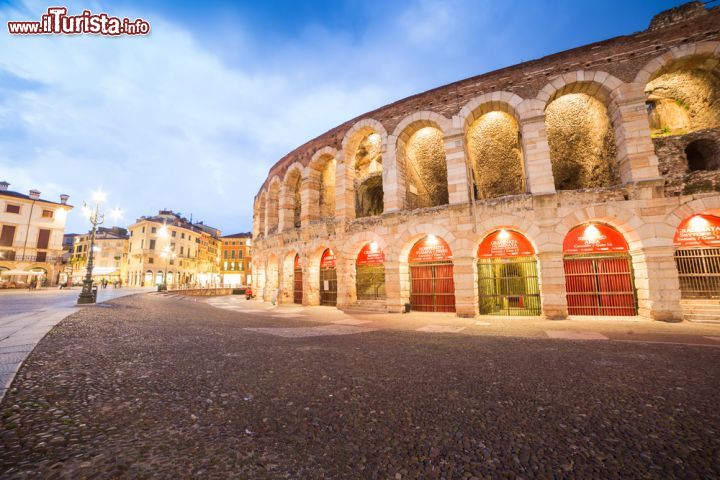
left=0, top=288, right=150, bottom=400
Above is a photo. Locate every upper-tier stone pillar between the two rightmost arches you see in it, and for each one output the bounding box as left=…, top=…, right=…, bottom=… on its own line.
left=608, top=83, right=660, bottom=183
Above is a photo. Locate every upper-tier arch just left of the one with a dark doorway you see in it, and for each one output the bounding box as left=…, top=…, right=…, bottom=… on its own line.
left=305, top=147, right=338, bottom=221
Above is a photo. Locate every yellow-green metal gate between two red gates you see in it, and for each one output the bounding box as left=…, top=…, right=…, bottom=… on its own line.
left=478, top=256, right=540, bottom=316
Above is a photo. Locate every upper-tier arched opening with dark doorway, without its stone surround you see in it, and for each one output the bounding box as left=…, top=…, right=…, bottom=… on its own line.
left=353, top=132, right=384, bottom=218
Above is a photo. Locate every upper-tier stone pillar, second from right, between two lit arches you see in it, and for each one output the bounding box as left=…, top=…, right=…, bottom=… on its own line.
left=520, top=114, right=555, bottom=195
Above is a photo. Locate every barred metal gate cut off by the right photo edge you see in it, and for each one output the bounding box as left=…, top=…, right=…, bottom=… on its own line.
left=675, top=248, right=720, bottom=299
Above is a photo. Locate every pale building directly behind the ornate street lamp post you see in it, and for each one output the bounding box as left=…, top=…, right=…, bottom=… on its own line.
left=69, top=227, right=130, bottom=285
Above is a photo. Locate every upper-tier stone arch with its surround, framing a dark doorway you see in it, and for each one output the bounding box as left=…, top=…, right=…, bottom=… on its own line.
left=336, top=118, right=387, bottom=218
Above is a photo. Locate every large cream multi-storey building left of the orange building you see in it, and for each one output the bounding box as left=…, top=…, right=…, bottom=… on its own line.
left=127, top=210, right=220, bottom=287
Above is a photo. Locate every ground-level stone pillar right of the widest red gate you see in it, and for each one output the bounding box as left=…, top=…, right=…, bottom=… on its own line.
left=630, top=245, right=683, bottom=322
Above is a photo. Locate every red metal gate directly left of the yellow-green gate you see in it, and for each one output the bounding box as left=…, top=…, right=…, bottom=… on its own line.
left=410, top=262, right=455, bottom=312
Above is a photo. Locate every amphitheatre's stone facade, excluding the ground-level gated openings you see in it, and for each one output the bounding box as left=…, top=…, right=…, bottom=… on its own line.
left=253, top=2, right=720, bottom=321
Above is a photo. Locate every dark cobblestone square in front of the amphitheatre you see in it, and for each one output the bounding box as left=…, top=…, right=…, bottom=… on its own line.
left=0, top=295, right=720, bottom=479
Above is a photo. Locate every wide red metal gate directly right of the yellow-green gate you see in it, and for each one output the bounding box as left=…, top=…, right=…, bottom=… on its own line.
left=564, top=254, right=637, bottom=316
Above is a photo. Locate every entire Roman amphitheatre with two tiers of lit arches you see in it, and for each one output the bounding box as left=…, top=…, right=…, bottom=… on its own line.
left=253, top=2, right=720, bottom=321
